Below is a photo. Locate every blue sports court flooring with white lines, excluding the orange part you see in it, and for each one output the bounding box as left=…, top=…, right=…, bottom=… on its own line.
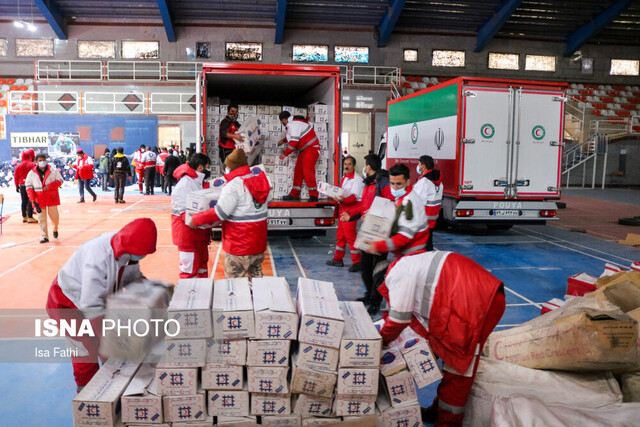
left=0, top=189, right=640, bottom=427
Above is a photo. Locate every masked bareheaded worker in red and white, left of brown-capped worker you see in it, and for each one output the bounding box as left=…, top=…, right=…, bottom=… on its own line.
left=171, top=153, right=211, bottom=279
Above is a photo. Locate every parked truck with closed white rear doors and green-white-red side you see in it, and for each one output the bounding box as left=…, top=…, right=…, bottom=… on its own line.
left=385, top=77, right=566, bottom=228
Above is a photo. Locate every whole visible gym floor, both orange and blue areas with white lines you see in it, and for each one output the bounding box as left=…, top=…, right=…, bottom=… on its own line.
left=0, top=187, right=640, bottom=427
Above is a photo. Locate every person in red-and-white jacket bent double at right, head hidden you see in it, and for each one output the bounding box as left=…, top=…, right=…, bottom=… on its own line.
left=379, top=250, right=505, bottom=426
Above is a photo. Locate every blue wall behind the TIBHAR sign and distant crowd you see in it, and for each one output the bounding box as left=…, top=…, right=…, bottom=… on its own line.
left=0, top=114, right=158, bottom=161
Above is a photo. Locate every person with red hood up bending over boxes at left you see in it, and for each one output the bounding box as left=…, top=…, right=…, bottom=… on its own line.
left=46, top=218, right=158, bottom=391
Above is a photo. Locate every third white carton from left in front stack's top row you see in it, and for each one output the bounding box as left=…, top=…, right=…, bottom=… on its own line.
left=252, top=277, right=298, bottom=340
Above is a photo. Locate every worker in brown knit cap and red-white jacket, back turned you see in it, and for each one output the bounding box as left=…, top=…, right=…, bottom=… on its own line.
left=192, top=148, right=271, bottom=278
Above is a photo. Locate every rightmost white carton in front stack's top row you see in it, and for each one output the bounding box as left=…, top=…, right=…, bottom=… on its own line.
left=340, top=301, right=382, bottom=368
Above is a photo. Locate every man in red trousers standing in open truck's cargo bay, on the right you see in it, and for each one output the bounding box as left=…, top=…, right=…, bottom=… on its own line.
left=278, top=111, right=320, bottom=202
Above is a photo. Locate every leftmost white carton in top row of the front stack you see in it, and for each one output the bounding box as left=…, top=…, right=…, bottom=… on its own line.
left=168, top=279, right=213, bottom=338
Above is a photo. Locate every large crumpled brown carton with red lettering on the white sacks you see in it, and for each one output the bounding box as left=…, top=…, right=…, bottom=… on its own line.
left=485, top=304, right=638, bottom=371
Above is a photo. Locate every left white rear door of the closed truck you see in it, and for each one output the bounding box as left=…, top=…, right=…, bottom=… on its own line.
left=459, top=85, right=513, bottom=196
